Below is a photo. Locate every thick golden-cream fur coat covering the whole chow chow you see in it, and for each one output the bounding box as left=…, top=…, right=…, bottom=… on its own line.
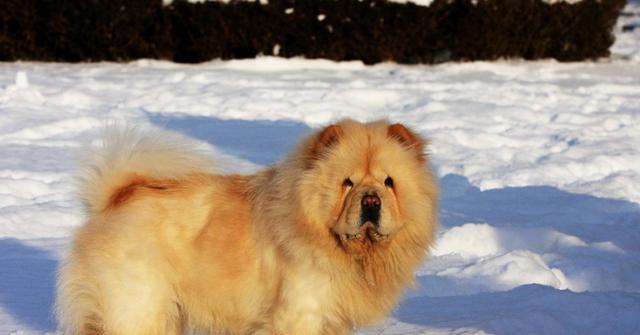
left=57, top=120, right=437, bottom=335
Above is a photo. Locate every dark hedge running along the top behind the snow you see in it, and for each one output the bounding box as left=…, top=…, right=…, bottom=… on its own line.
left=0, top=0, right=625, bottom=64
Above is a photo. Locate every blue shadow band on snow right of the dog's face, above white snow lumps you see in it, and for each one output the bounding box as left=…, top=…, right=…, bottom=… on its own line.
left=440, top=175, right=640, bottom=250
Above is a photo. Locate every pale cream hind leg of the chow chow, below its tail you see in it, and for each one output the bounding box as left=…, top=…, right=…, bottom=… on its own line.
left=57, top=243, right=183, bottom=335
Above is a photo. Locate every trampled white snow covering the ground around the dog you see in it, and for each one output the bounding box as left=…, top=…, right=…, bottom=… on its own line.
left=0, top=5, right=640, bottom=334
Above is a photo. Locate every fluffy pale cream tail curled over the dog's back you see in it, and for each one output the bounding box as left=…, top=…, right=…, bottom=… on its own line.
left=79, top=126, right=213, bottom=213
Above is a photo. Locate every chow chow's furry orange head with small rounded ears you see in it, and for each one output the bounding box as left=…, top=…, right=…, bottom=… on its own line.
left=298, top=120, right=437, bottom=254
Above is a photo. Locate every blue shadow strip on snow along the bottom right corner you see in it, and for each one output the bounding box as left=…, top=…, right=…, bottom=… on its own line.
left=395, top=285, right=640, bottom=335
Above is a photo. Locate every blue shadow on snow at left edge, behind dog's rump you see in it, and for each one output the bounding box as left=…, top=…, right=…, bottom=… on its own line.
left=0, top=239, right=58, bottom=332
